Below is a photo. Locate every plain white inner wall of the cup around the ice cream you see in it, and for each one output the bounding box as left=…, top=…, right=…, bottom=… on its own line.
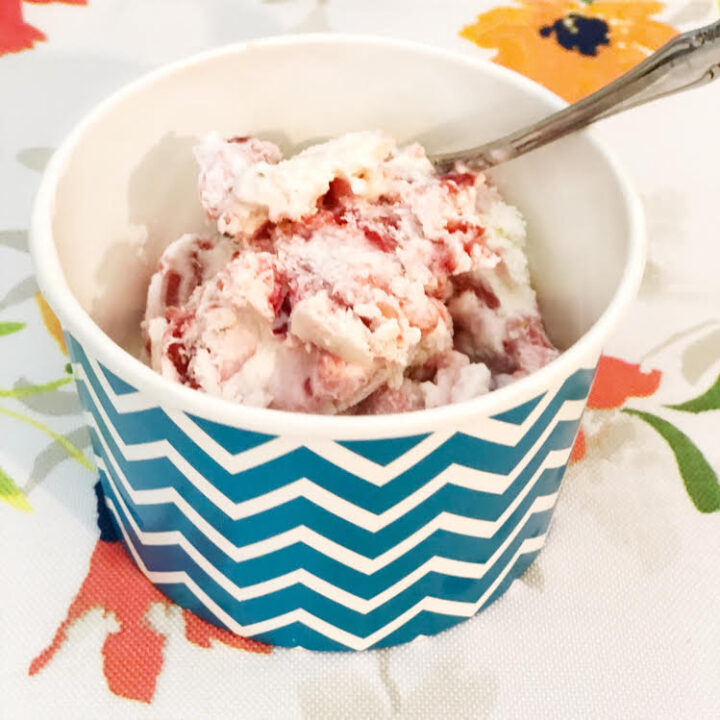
left=47, top=36, right=631, bottom=354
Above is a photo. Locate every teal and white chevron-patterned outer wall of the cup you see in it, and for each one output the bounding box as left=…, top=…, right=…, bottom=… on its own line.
left=67, top=336, right=594, bottom=650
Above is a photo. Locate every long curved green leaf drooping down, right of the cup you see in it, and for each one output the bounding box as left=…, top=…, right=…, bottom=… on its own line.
left=623, top=408, right=720, bottom=513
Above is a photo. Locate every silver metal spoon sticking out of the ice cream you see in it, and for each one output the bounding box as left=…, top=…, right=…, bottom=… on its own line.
left=432, top=21, right=720, bottom=172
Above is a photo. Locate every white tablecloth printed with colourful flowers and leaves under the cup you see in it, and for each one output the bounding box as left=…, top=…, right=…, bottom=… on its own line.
left=0, top=0, right=720, bottom=720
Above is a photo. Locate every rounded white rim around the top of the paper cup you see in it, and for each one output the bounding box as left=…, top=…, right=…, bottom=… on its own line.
left=30, top=33, right=647, bottom=440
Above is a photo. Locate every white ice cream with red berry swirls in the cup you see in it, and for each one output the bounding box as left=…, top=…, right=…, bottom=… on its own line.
left=143, top=132, right=557, bottom=414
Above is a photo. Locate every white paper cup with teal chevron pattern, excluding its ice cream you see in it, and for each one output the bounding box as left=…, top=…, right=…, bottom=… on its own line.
left=31, top=35, right=645, bottom=650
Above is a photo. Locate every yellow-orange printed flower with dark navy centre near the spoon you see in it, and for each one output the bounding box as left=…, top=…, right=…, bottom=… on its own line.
left=460, top=0, right=677, bottom=102
